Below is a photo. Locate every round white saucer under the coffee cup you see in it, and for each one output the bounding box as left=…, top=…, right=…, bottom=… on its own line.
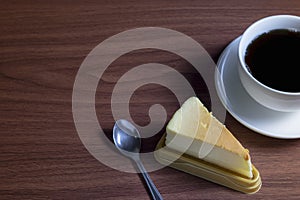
left=215, top=37, right=300, bottom=139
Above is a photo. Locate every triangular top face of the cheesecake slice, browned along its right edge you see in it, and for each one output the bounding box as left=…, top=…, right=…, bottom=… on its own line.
left=166, top=97, right=250, bottom=160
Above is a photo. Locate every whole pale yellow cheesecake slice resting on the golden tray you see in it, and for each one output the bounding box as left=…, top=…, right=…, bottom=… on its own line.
left=166, top=97, right=253, bottom=178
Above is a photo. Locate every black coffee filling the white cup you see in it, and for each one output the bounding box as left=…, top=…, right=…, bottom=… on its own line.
left=245, top=29, right=300, bottom=92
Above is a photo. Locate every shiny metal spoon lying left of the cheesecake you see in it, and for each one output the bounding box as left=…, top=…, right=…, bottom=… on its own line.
left=113, top=119, right=163, bottom=200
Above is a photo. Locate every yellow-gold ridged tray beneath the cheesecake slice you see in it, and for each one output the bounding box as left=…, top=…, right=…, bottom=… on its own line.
left=154, top=134, right=262, bottom=194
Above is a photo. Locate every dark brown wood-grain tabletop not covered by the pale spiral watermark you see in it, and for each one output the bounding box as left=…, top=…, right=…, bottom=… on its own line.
left=0, top=0, right=300, bottom=200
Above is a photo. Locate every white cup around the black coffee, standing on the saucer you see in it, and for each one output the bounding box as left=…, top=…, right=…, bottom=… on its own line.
left=238, top=15, right=300, bottom=112
